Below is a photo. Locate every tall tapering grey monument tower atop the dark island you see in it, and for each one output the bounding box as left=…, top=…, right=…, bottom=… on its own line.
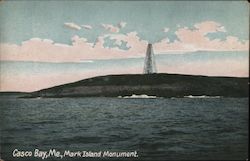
left=143, top=44, right=157, bottom=74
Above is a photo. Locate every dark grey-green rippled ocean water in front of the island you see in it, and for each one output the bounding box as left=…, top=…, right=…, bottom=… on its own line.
left=0, top=97, right=249, bottom=161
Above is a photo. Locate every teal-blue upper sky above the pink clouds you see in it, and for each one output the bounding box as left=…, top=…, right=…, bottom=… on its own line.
left=0, top=1, right=249, bottom=44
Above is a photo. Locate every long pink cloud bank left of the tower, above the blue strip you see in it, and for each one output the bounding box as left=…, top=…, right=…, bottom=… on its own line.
left=0, top=32, right=147, bottom=62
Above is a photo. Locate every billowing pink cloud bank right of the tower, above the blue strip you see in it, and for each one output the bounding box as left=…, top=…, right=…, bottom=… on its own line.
left=154, top=21, right=249, bottom=53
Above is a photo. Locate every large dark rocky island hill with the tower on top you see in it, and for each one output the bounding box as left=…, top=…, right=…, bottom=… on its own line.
left=25, top=73, right=249, bottom=98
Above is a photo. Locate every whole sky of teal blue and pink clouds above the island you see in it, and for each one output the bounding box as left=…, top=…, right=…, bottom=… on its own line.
left=0, top=0, right=249, bottom=92
